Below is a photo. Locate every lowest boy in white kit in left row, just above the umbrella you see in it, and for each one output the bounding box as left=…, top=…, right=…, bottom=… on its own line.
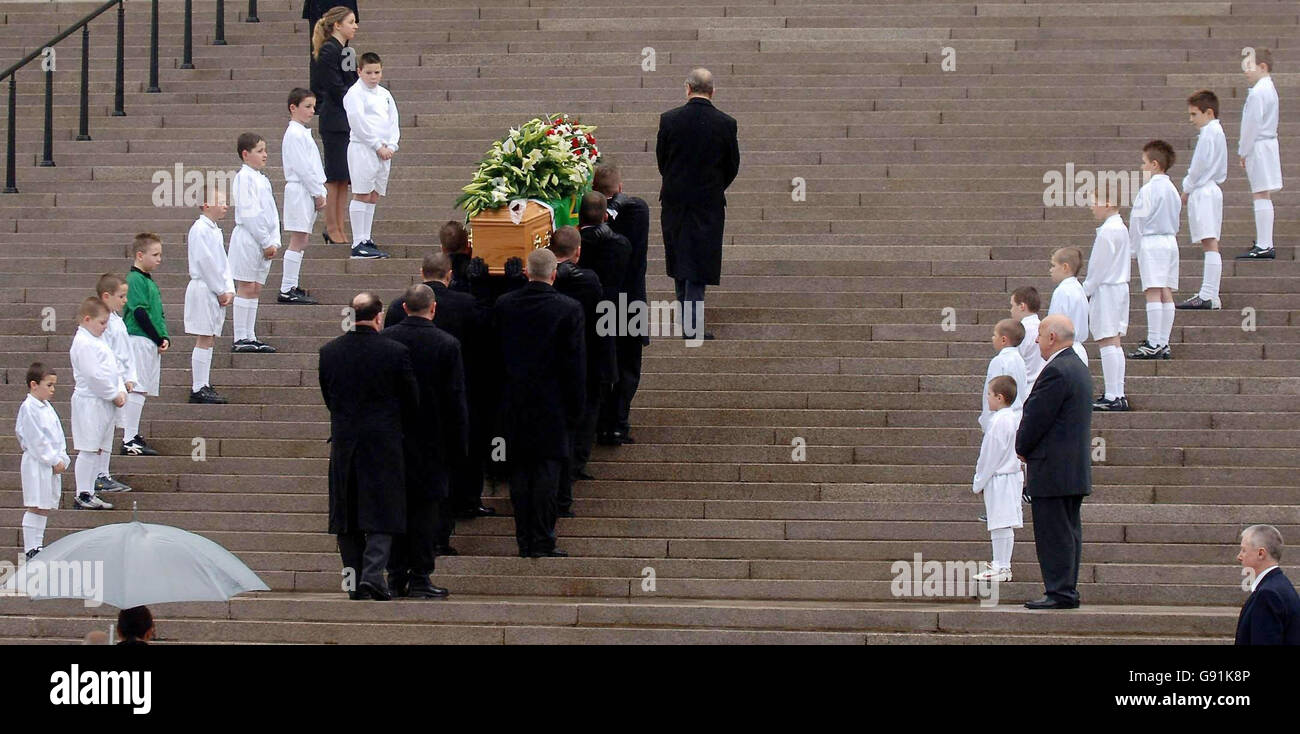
left=14, top=362, right=73, bottom=560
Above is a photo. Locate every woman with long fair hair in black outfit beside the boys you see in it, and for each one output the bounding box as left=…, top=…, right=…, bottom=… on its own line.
left=312, top=6, right=358, bottom=243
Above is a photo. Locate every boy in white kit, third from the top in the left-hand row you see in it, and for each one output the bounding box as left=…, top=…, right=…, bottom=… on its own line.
left=229, top=133, right=280, bottom=352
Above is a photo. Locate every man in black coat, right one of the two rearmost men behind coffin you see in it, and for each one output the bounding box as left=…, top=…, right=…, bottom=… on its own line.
left=384, top=283, right=469, bottom=599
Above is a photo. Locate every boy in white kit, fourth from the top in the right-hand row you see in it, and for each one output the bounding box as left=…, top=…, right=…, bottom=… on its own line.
left=1083, top=181, right=1130, bottom=411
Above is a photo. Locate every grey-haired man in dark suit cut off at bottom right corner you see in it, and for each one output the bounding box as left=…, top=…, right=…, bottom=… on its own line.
left=1236, top=525, right=1300, bottom=644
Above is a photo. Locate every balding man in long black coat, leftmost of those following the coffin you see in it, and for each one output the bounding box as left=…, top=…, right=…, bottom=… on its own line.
left=317, top=292, right=420, bottom=601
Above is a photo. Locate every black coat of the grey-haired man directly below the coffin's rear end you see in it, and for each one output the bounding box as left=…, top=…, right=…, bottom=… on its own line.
left=493, top=282, right=586, bottom=462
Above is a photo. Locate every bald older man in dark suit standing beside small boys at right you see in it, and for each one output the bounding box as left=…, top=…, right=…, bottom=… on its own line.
left=1015, top=314, right=1092, bottom=609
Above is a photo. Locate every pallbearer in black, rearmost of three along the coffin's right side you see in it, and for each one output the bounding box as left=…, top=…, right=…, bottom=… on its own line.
left=550, top=227, right=615, bottom=517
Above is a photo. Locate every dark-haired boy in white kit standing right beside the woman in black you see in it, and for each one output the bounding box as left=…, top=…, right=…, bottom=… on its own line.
left=343, top=53, right=402, bottom=260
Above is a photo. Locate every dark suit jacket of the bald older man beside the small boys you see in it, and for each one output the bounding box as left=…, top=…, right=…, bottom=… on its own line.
left=1015, top=348, right=1092, bottom=498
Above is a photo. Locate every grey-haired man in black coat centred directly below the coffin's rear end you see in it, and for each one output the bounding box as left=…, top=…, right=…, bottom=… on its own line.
left=493, top=249, right=586, bottom=557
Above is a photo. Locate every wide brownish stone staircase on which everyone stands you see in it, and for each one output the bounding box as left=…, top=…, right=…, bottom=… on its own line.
left=0, top=0, right=1300, bottom=644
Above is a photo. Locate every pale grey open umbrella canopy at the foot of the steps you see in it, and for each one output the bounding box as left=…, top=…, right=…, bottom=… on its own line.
left=17, top=514, right=270, bottom=609
